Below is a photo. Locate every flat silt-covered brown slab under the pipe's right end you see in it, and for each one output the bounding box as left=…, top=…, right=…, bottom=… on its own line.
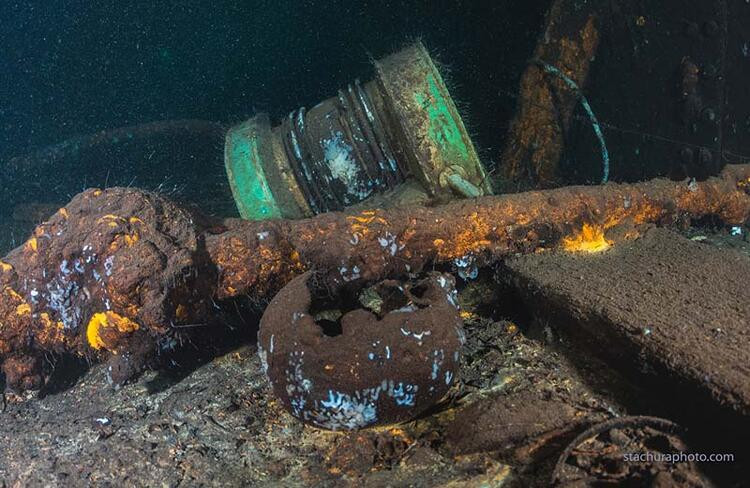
left=502, top=229, right=750, bottom=458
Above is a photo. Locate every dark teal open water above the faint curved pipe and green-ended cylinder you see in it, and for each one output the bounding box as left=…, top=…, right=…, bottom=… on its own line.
left=0, top=0, right=549, bottom=165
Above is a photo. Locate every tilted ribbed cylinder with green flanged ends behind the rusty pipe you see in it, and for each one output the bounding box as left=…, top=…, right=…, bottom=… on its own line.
left=225, top=42, right=492, bottom=220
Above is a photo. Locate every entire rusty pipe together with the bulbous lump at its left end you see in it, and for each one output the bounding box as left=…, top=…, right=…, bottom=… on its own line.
left=0, top=165, right=750, bottom=389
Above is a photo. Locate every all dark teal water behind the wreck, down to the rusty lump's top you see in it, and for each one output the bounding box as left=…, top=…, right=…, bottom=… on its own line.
left=0, top=0, right=551, bottom=252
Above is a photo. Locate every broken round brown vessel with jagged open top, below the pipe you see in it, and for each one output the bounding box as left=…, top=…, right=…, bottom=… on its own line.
left=258, top=273, right=464, bottom=430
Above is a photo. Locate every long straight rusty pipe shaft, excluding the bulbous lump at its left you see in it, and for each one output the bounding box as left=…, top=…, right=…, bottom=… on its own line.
left=206, top=165, right=750, bottom=299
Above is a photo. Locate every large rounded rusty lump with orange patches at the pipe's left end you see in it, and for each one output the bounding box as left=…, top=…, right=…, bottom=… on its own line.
left=0, top=189, right=212, bottom=390
